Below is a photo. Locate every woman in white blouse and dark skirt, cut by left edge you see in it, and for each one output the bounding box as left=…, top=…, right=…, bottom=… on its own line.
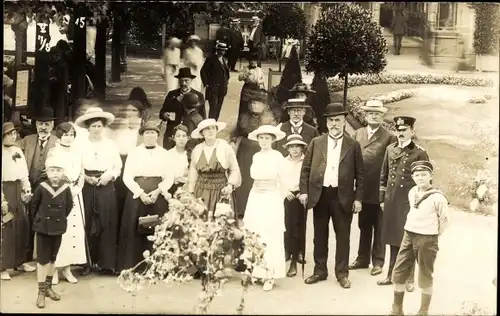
left=0, top=122, right=31, bottom=280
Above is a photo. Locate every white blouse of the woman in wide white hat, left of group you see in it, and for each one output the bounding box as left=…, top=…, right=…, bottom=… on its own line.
left=81, top=137, right=122, bottom=178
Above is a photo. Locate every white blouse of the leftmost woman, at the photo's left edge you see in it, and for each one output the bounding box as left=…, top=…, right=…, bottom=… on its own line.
left=2, top=145, right=31, bottom=192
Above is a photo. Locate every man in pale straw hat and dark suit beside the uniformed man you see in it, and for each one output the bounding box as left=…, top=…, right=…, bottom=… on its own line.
left=349, top=100, right=397, bottom=275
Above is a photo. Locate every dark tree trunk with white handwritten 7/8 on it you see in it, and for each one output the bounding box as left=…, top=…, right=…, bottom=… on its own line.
left=32, top=19, right=50, bottom=114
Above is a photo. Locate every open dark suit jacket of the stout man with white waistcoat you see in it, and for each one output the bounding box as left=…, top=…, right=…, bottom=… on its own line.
left=299, top=133, right=364, bottom=212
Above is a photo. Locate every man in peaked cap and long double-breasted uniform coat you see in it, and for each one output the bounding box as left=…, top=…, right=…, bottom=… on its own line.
left=377, top=116, right=429, bottom=292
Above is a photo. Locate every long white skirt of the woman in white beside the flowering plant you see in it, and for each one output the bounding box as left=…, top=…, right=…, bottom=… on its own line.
left=243, top=185, right=286, bottom=279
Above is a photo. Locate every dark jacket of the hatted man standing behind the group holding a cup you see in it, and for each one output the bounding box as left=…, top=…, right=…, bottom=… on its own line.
left=160, top=88, right=207, bottom=137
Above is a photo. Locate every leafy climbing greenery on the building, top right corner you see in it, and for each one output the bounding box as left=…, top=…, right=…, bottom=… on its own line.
left=472, top=2, right=500, bottom=55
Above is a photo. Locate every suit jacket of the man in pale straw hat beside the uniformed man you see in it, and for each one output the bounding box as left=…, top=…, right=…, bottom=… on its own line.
left=354, top=126, right=397, bottom=204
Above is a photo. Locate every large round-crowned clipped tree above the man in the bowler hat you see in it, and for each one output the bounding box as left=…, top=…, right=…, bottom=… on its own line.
left=305, top=3, right=388, bottom=107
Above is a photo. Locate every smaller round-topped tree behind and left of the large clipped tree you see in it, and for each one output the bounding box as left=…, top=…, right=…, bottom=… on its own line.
left=262, top=2, right=306, bottom=71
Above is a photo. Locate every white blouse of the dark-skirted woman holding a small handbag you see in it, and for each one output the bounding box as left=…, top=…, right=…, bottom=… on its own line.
left=123, top=145, right=174, bottom=199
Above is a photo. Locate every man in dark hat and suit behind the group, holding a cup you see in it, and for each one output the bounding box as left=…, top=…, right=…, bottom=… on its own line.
left=160, top=67, right=207, bottom=149
